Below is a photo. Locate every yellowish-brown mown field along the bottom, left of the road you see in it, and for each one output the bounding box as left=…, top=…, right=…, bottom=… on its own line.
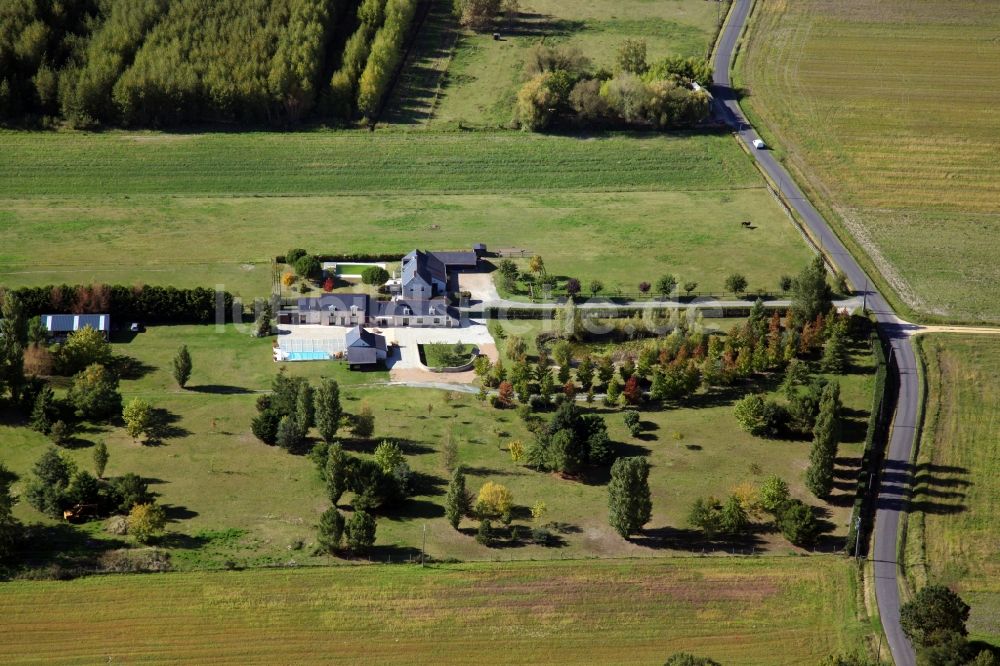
left=0, top=558, right=865, bottom=665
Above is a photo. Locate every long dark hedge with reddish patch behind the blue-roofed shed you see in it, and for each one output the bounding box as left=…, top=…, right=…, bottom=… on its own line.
left=12, top=284, right=233, bottom=324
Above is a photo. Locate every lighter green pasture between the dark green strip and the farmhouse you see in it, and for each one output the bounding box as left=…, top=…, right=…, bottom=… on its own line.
left=0, top=184, right=810, bottom=297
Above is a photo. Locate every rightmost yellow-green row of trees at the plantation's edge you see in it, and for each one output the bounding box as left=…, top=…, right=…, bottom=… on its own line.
left=358, top=0, right=417, bottom=118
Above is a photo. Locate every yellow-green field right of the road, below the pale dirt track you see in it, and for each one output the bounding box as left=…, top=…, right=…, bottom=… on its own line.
left=907, top=335, right=1000, bottom=646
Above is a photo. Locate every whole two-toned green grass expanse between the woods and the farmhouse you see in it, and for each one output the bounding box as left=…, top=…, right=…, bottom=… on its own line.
left=0, top=132, right=809, bottom=297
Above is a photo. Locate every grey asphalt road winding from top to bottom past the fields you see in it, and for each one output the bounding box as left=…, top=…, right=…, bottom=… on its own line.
left=712, top=0, right=920, bottom=666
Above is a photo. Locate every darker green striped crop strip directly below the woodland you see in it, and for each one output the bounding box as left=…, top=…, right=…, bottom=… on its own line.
left=0, top=131, right=761, bottom=198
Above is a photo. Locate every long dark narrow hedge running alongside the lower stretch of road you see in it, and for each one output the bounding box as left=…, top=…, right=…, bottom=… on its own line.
left=845, top=332, right=892, bottom=553
